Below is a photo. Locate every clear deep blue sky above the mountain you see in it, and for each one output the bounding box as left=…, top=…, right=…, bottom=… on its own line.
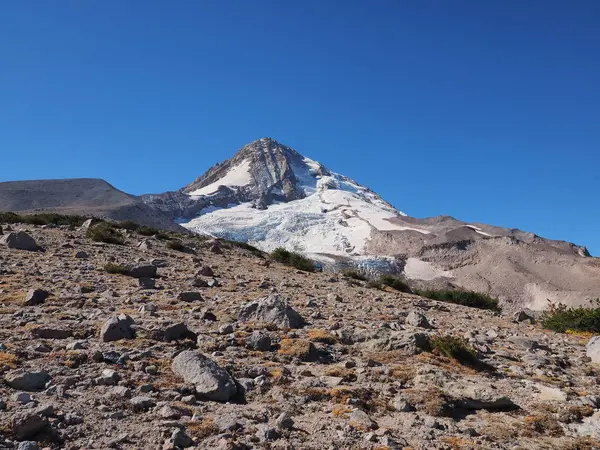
left=0, top=0, right=600, bottom=255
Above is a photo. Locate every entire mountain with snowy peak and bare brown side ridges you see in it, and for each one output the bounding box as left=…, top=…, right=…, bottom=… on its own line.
left=0, top=138, right=600, bottom=309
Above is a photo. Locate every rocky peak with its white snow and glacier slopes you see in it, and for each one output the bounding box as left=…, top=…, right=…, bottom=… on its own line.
left=176, top=138, right=427, bottom=256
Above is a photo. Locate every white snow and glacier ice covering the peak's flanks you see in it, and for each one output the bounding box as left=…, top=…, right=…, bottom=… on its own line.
left=182, top=151, right=429, bottom=256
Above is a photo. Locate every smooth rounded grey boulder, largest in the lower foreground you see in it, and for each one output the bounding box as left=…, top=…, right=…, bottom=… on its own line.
left=171, top=350, right=237, bottom=402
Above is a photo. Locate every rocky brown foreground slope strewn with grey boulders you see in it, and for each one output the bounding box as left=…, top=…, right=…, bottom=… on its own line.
left=0, top=225, right=600, bottom=450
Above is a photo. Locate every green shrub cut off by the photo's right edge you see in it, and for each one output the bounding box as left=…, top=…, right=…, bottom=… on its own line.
left=541, top=301, right=600, bottom=333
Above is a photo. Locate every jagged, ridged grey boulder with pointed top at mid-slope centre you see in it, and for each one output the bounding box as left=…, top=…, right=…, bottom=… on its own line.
left=238, top=294, right=305, bottom=328
